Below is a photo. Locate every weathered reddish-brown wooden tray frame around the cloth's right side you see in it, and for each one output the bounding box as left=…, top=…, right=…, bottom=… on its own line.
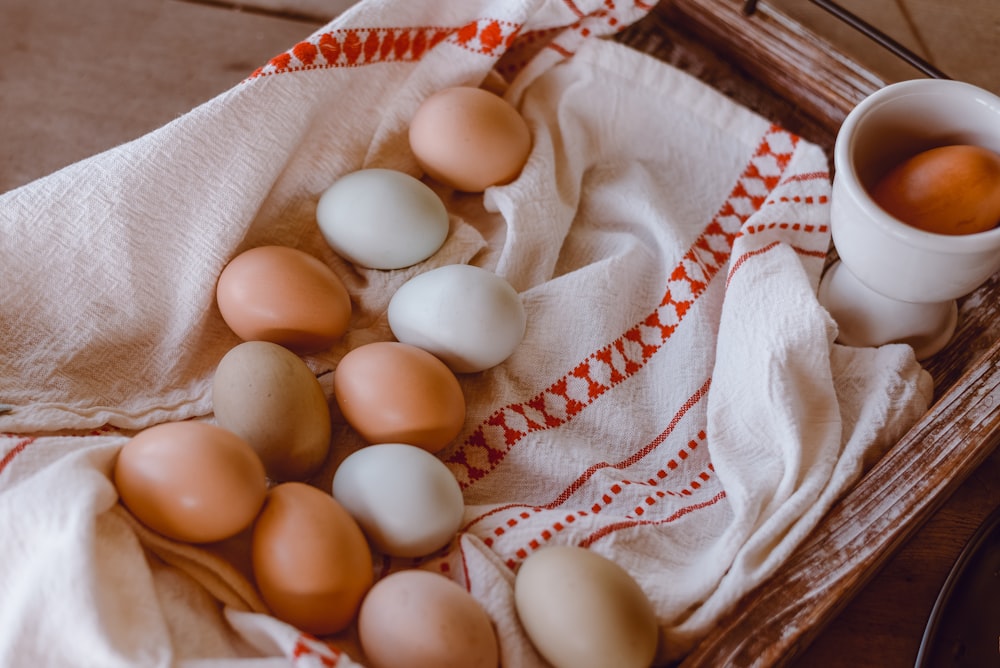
left=618, top=0, right=1000, bottom=668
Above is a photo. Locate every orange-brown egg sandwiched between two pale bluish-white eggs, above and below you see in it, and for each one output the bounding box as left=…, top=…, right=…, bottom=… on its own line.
left=333, top=341, right=465, bottom=452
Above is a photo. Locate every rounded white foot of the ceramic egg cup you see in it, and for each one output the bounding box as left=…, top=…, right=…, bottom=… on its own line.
left=818, top=260, right=958, bottom=361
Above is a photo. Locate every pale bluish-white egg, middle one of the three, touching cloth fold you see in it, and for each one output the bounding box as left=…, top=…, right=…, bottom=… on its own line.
left=388, top=264, right=527, bottom=373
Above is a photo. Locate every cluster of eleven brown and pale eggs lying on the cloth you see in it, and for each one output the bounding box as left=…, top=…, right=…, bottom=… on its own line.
left=114, top=87, right=656, bottom=668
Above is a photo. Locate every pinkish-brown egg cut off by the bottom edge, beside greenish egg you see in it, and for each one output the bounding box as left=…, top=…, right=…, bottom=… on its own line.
left=358, top=569, right=500, bottom=668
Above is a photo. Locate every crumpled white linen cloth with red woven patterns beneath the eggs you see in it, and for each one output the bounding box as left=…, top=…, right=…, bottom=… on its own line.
left=0, top=0, right=931, bottom=668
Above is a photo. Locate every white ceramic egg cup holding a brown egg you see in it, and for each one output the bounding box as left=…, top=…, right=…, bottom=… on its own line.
left=819, top=79, right=1000, bottom=360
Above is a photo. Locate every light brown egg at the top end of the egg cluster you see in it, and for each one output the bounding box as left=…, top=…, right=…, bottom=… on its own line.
left=409, top=86, right=531, bottom=192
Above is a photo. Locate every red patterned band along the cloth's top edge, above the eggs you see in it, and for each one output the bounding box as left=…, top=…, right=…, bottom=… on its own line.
left=248, top=18, right=521, bottom=79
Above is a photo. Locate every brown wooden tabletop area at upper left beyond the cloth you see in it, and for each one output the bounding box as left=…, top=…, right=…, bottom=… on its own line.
left=0, top=0, right=319, bottom=192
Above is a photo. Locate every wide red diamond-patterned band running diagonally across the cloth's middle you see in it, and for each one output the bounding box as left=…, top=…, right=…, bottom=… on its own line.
left=445, top=126, right=799, bottom=489
